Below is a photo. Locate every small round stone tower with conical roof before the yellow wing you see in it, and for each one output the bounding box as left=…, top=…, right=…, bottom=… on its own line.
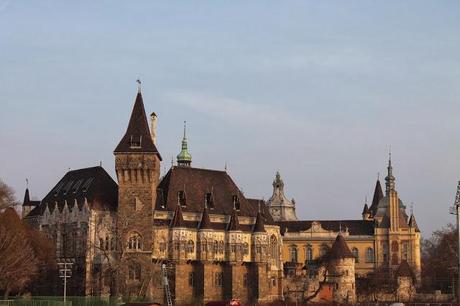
left=328, top=234, right=356, bottom=304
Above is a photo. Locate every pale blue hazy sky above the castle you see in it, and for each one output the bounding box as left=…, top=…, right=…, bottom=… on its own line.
left=0, top=0, right=460, bottom=237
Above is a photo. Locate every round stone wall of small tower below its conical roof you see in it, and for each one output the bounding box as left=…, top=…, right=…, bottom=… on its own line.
left=329, top=258, right=356, bottom=304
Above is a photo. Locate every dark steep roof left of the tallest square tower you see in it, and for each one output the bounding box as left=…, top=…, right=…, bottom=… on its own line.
left=28, top=166, right=118, bottom=216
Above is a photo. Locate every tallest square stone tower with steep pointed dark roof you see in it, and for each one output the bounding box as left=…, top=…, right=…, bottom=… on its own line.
left=114, top=86, right=161, bottom=290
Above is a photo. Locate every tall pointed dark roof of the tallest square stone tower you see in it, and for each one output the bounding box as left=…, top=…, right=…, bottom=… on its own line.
left=114, top=92, right=161, bottom=160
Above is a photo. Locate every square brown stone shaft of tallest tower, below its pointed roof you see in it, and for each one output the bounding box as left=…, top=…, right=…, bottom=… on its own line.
left=115, top=153, right=160, bottom=294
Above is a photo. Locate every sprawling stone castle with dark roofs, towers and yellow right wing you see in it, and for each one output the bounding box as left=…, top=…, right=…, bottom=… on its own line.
left=23, top=89, right=420, bottom=304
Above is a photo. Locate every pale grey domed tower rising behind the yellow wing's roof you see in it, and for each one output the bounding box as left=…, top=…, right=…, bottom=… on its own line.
left=267, top=172, right=297, bottom=221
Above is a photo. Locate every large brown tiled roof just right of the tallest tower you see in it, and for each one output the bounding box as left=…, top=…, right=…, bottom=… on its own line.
left=155, top=167, right=274, bottom=224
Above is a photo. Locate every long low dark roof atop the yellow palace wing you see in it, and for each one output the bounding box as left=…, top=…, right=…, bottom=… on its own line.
left=276, top=220, right=374, bottom=236
